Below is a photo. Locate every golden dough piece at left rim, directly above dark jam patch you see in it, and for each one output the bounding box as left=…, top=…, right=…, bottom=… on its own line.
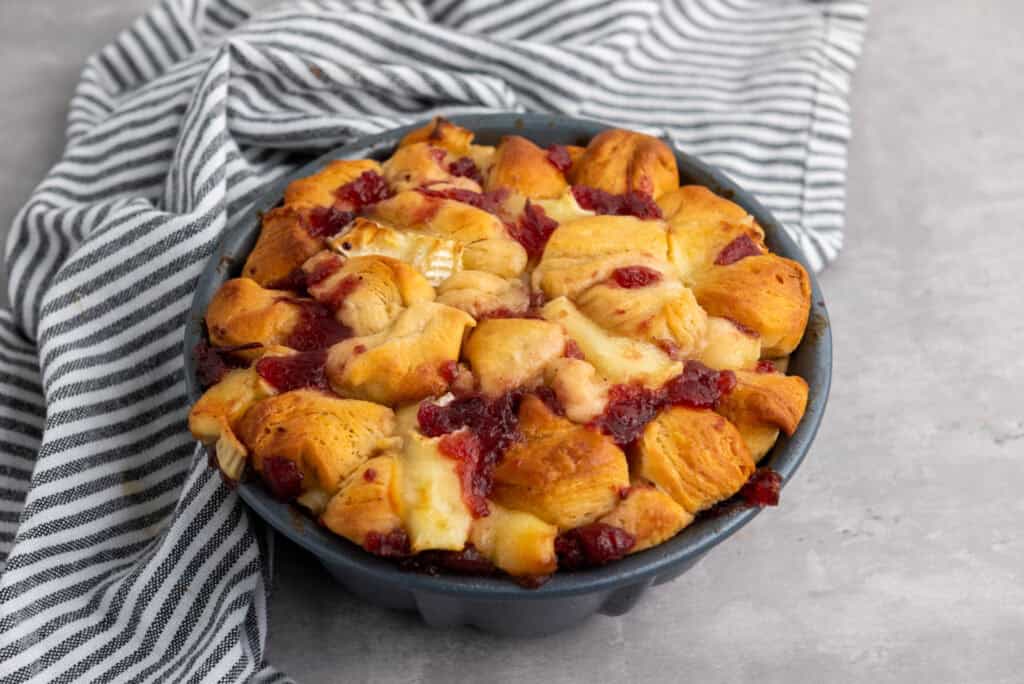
left=206, top=277, right=301, bottom=358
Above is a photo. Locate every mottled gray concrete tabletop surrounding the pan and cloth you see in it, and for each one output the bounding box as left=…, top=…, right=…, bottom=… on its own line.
left=0, top=0, right=1024, bottom=684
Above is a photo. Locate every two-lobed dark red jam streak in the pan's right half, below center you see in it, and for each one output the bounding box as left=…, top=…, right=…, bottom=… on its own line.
left=592, top=360, right=736, bottom=445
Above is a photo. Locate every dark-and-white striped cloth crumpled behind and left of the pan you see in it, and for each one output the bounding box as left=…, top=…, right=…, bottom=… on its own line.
left=0, top=0, right=866, bottom=682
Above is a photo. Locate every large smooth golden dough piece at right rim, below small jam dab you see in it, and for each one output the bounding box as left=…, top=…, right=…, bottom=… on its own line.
left=693, top=254, right=811, bottom=357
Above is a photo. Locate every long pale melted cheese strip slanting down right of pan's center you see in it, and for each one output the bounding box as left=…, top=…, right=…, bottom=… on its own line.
left=541, top=297, right=683, bottom=387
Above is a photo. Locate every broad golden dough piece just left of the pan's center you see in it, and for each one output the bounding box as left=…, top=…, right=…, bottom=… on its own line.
left=327, top=302, right=476, bottom=405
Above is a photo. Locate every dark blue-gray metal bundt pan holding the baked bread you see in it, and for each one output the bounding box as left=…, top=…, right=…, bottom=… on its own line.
left=184, top=114, right=831, bottom=636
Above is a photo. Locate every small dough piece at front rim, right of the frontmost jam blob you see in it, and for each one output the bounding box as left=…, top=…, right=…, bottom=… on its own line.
left=598, top=483, right=693, bottom=553
